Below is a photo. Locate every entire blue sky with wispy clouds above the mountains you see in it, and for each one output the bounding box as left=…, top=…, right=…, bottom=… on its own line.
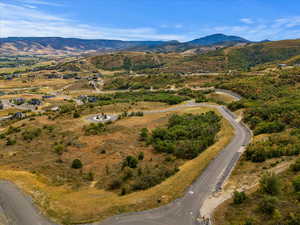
left=0, top=0, right=300, bottom=41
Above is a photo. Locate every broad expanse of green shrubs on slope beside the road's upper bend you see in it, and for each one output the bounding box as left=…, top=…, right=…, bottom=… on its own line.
left=218, top=73, right=300, bottom=134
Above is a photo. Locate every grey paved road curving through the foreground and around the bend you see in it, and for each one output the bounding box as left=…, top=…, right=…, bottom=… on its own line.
left=0, top=91, right=251, bottom=225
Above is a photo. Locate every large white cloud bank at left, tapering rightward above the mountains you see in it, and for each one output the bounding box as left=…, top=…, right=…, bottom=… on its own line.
left=0, top=0, right=186, bottom=40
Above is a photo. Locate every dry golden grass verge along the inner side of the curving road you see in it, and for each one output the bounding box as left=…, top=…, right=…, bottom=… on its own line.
left=0, top=105, right=234, bottom=223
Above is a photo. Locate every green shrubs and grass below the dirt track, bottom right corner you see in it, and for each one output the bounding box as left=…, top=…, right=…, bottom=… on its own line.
left=215, top=159, right=300, bottom=225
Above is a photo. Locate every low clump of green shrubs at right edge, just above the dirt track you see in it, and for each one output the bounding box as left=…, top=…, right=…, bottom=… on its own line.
left=245, top=133, right=300, bottom=162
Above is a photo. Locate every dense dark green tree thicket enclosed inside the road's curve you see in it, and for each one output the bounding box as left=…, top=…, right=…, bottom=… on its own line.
left=144, top=111, right=220, bottom=159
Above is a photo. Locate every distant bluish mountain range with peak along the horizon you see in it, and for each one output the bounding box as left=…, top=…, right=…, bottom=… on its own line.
left=0, top=34, right=251, bottom=54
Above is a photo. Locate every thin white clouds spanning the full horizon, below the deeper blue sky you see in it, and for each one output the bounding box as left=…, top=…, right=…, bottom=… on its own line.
left=0, top=0, right=300, bottom=41
